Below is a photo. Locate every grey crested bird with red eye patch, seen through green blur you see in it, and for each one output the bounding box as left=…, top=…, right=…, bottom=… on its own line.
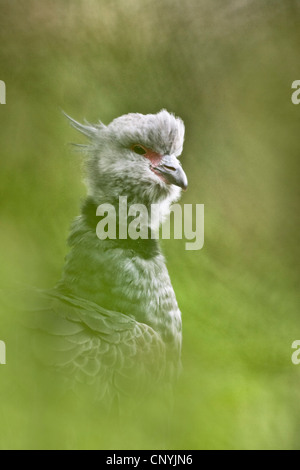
left=17, top=109, right=188, bottom=412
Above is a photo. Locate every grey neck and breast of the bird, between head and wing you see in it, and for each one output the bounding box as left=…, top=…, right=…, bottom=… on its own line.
left=57, top=198, right=181, bottom=358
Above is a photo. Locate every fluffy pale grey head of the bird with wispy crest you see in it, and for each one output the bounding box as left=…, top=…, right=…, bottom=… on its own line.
left=67, top=110, right=187, bottom=204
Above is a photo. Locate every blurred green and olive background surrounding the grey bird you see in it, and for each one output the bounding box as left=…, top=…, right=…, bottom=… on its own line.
left=0, top=0, right=300, bottom=449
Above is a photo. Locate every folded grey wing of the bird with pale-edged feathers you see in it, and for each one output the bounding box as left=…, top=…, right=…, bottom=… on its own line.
left=9, top=290, right=166, bottom=403
